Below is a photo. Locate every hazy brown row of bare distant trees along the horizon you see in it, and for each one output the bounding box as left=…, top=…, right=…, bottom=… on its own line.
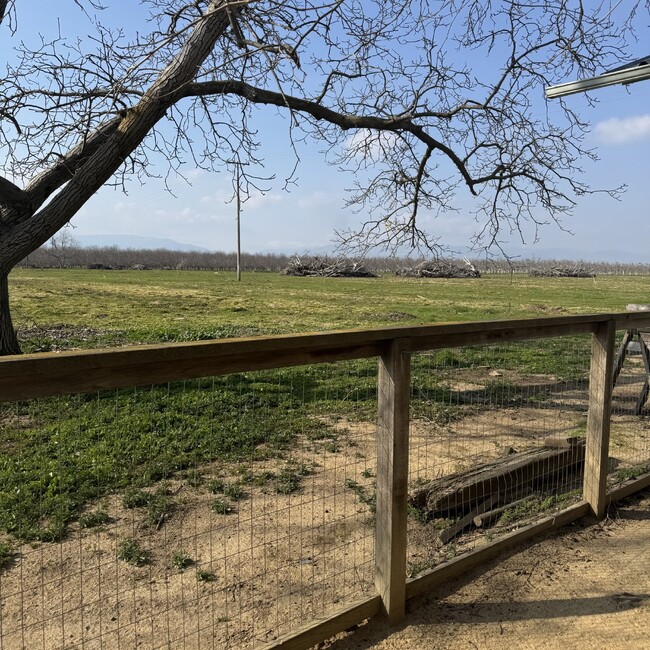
left=13, top=242, right=650, bottom=275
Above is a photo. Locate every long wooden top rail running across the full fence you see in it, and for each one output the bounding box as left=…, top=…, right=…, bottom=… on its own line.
left=0, top=312, right=650, bottom=401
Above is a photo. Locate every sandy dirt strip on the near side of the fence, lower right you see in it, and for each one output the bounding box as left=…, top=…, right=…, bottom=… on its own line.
left=321, top=490, right=650, bottom=650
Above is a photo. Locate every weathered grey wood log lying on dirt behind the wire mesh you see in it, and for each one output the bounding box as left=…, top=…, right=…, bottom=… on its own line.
left=410, top=440, right=585, bottom=518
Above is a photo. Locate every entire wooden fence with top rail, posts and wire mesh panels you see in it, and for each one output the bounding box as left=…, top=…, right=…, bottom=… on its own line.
left=0, top=312, right=650, bottom=649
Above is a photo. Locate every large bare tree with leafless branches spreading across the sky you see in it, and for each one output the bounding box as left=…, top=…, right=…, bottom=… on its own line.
left=0, top=0, right=648, bottom=354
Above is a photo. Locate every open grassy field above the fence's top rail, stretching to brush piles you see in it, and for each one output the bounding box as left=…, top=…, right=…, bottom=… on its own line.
left=10, top=269, right=650, bottom=351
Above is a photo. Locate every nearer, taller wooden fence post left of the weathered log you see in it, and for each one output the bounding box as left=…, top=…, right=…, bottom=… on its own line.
left=375, top=339, right=411, bottom=624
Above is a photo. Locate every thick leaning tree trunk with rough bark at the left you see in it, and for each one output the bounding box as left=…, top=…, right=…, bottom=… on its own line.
left=0, top=0, right=233, bottom=356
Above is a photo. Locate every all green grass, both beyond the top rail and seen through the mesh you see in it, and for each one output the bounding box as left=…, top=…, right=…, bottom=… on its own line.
left=0, top=270, right=650, bottom=541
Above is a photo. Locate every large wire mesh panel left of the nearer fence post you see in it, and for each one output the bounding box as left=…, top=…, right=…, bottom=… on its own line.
left=0, top=362, right=376, bottom=650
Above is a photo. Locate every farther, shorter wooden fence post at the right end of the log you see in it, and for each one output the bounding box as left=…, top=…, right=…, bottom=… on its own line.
left=583, top=320, right=616, bottom=519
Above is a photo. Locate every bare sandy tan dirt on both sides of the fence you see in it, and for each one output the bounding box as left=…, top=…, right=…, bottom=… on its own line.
left=0, top=364, right=650, bottom=650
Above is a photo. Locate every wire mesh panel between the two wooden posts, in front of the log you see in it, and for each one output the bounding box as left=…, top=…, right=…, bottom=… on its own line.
left=408, top=336, right=590, bottom=576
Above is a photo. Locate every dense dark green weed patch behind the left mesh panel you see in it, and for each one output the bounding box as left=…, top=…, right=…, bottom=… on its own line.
left=0, top=376, right=334, bottom=541
